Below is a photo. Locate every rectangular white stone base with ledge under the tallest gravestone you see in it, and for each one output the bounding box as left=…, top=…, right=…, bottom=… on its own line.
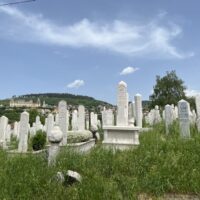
left=103, top=126, right=141, bottom=150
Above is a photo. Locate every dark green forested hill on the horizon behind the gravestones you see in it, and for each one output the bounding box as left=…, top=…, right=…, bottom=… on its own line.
left=5, top=93, right=112, bottom=107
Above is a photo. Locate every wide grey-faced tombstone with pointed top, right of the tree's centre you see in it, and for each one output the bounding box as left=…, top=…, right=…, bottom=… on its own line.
left=178, top=100, right=190, bottom=138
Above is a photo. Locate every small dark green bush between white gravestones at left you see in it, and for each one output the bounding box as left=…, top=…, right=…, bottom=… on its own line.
left=32, top=131, right=46, bottom=151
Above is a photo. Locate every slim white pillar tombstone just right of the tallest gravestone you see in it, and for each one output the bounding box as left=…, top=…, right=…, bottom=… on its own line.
left=135, top=94, right=142, bottom=128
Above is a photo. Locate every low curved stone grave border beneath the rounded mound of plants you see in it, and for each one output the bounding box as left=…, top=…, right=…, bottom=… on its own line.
left=61, top=139, right=95, bottom=153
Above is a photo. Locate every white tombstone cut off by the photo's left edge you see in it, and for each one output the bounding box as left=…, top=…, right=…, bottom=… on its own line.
left=0, top=116, right=8, bottom=148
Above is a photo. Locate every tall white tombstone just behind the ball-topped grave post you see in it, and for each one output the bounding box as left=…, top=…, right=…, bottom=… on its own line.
left=58, top=101, right=68, bottom=146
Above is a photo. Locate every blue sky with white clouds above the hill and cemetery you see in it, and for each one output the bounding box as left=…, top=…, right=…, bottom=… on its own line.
left=0, top=0, right=200, bottom=103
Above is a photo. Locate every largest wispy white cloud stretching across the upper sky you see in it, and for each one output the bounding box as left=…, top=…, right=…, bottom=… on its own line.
left=0, top=7, right=194, bottom=59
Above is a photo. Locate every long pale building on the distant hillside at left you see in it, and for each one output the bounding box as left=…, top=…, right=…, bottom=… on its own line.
left=10, top=98, right=41, bottom=108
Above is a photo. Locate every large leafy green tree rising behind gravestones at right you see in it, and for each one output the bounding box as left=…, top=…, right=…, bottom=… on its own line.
left=150, top=71, right=186, bottom=107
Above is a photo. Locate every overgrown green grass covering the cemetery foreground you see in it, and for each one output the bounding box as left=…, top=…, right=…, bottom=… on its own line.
left=0, top=122, right=200, bottom=200
